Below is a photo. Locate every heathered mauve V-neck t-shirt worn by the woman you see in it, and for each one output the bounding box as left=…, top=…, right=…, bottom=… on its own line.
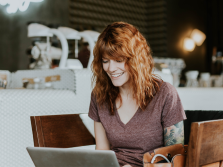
left=88, top=82, right=186, bottom=167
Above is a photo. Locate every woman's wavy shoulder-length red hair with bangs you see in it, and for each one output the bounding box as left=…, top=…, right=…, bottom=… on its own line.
left=91, top=22, right=160, bottom=115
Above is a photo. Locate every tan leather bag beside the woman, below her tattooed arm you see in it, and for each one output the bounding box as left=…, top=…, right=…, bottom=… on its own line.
left=143, top=144, right=187, bottom=167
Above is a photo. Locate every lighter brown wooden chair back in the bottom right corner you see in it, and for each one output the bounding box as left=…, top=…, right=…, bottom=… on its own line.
left=186, top=119, right=223, bottom=167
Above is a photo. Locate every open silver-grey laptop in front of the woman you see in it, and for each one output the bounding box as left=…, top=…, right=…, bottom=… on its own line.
left=26, top=147, right=120, bottom=167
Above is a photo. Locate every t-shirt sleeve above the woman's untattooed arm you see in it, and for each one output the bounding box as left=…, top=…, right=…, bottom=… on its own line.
left=88, top=92, right=101, bottom=122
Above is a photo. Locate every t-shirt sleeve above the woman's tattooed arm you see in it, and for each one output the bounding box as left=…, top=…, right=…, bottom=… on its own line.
left=162, top=83, right=187, bottom=128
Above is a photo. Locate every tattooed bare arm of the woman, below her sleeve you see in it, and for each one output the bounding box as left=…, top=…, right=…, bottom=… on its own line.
left=164, top=121, right=184, bottom=146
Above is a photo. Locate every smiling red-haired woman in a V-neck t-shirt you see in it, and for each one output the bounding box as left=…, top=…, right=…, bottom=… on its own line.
left=89, top=22, right=186, bottom=167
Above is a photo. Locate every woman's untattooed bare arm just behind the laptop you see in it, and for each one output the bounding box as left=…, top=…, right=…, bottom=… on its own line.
left=94, top=121, right=110, bottom=150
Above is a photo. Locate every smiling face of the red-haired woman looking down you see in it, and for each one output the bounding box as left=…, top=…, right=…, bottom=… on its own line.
left=102, top=58, right=129, bottom=87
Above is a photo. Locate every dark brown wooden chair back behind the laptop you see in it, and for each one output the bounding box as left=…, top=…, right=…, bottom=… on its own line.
left=30, top=114, right=95, bottom=148
